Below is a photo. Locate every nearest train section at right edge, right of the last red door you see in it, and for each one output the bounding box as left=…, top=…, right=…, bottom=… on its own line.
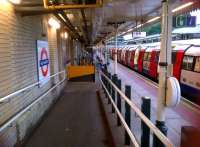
left=180, top=45, right=200, bottom=105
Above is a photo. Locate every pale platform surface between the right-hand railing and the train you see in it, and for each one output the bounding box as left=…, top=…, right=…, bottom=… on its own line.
left=108, top=60, right=200, bottom=147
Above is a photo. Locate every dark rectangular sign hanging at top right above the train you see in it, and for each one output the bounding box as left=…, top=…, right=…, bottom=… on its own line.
left=173, top=15, right=196, bottom=28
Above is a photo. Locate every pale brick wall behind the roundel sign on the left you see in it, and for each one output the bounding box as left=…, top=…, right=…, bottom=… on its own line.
left=0, top=3, right=66, bottom=147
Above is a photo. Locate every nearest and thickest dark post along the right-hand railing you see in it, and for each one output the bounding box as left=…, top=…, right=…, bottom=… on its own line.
left=141, top=97, right=151, bottom=147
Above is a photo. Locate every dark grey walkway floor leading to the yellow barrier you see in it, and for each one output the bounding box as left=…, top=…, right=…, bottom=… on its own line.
left=24, top=82, right=114, bottom=147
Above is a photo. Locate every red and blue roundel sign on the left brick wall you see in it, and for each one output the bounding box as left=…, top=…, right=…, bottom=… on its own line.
left=37, top=40, right=50, bottom=85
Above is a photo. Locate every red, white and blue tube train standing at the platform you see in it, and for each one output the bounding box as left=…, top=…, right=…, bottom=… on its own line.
left=105, top=39, right=200, bottom=105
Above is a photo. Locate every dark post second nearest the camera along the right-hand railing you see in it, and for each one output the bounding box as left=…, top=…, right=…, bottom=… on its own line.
left=125, top=85, right=131, bottom=145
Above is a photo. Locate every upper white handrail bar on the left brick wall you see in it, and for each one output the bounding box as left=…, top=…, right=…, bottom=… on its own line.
left=0, top=70, right=65, bottom=104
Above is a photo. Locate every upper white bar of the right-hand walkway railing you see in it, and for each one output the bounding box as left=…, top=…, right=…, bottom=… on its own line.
left=101, top=72, right=174, bottom=147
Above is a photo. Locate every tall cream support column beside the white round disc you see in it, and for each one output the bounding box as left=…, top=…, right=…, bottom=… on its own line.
left=154, top=0, right=172, bottom=147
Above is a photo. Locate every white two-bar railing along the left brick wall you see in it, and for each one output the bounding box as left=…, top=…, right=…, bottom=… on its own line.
left=0, top=70, right=66, bottom=132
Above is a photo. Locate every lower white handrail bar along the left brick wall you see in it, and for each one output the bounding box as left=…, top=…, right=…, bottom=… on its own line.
left=0, top=73, right=66, bottom=132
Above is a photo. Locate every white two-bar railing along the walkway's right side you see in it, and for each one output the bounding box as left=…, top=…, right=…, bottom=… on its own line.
left=100, top=72, right=174, bottom=147
